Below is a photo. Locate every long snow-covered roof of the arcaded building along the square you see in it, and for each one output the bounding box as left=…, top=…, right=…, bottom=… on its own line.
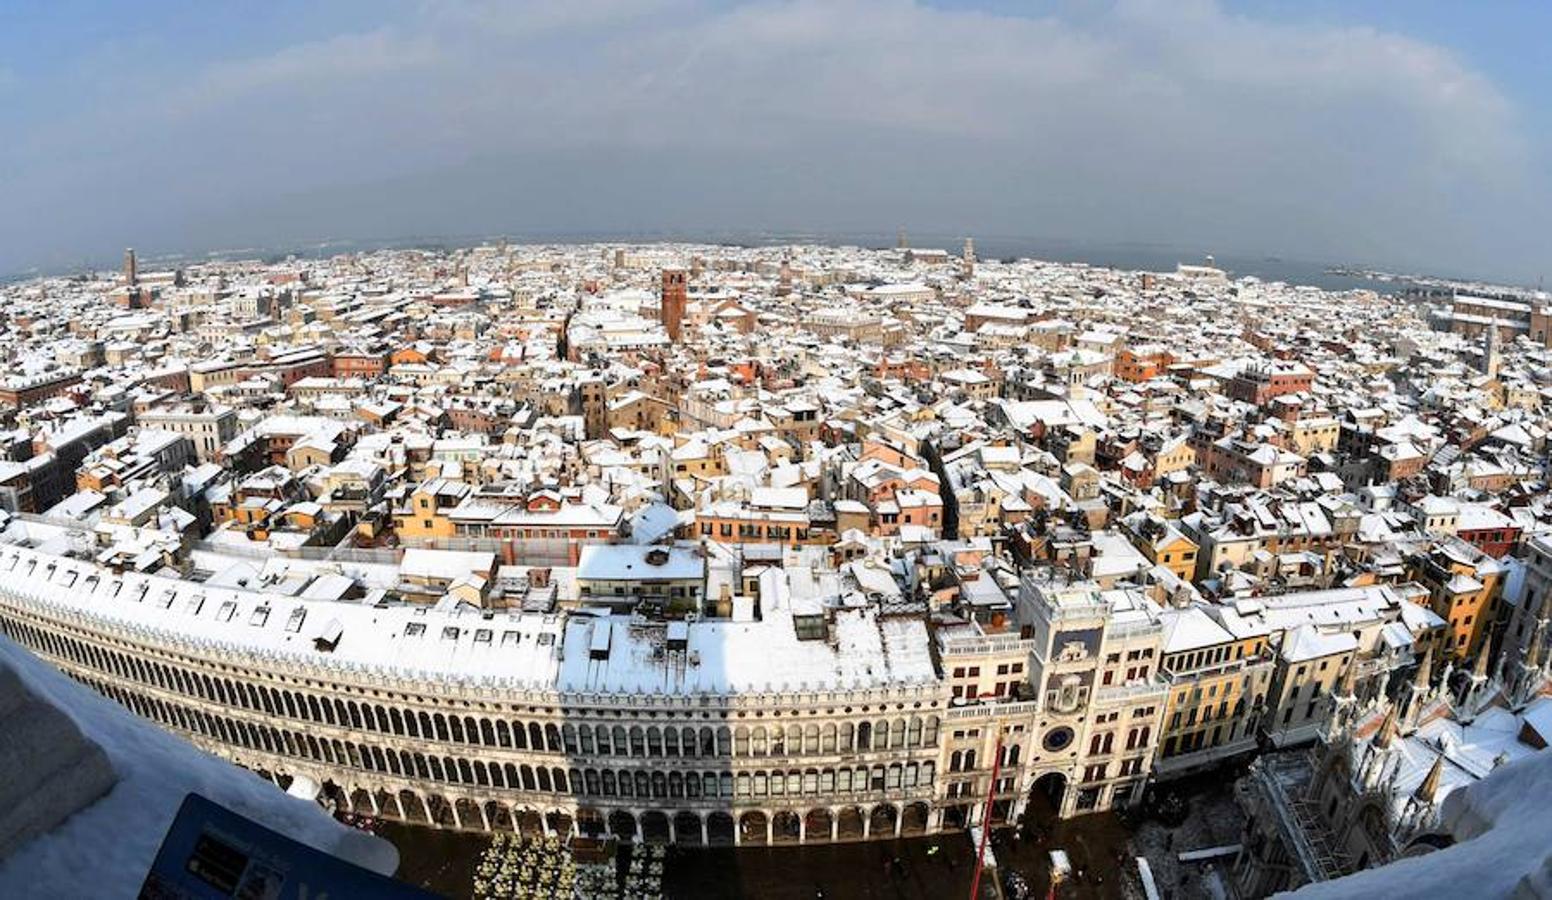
left=0, top=536, right=936, bottom=692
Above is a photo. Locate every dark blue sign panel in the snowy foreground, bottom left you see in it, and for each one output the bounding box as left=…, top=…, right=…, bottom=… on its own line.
left=140, top=794, right=436, bottom=900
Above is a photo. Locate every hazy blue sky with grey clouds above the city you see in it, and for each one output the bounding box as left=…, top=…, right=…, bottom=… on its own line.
left=0, top=0, right=1552, bottom=282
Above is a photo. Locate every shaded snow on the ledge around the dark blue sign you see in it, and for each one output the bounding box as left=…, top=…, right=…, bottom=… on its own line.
left=0, top=638, right=399, bottom=900
